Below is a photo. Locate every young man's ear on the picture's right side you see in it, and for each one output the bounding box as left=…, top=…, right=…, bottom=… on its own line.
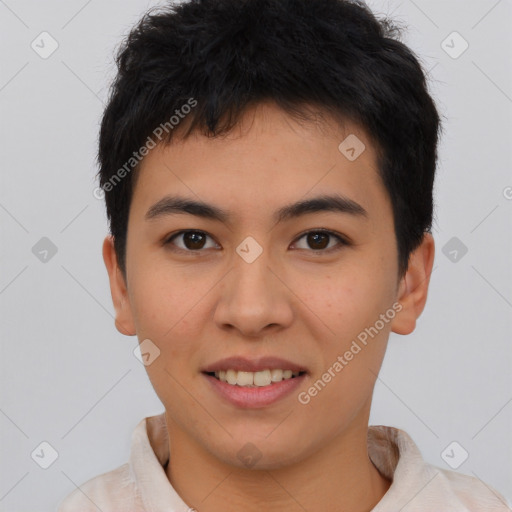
left=391, top=233, right=435, bottom=334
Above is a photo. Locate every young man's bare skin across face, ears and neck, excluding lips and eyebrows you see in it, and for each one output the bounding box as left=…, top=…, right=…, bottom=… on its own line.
left=103, top=103, right=434, bottom=512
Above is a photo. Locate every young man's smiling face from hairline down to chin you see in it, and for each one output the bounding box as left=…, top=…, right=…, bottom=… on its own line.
left=105, top=104, right=434, bottom=468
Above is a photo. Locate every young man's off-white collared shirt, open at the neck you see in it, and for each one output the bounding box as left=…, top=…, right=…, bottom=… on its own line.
left=58, top=413, right=511, bottom=512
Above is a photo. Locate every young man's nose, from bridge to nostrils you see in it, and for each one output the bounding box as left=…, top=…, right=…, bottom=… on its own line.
left=214, top=251, right=293, bottom=338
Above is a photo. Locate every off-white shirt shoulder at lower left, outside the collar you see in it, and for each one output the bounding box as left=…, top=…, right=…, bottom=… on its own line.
left=57, top=463, right=142, bottom=512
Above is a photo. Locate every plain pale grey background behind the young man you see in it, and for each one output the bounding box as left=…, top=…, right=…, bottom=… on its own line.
left=0, top=0, right=512, bottom=512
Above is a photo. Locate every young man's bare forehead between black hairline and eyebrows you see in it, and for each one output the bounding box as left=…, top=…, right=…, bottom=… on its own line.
left=132, top=104, right=387, bottom=224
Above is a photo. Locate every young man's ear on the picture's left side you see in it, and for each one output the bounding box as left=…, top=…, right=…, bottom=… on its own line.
left=103, top=235, right=136, bottom=336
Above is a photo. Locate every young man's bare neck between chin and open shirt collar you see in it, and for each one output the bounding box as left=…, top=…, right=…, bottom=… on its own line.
left=166, top=417, right=391, bottom=512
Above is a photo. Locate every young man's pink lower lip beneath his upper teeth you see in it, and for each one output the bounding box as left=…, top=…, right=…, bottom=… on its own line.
left=203, top=373, right=306, bottom=409
